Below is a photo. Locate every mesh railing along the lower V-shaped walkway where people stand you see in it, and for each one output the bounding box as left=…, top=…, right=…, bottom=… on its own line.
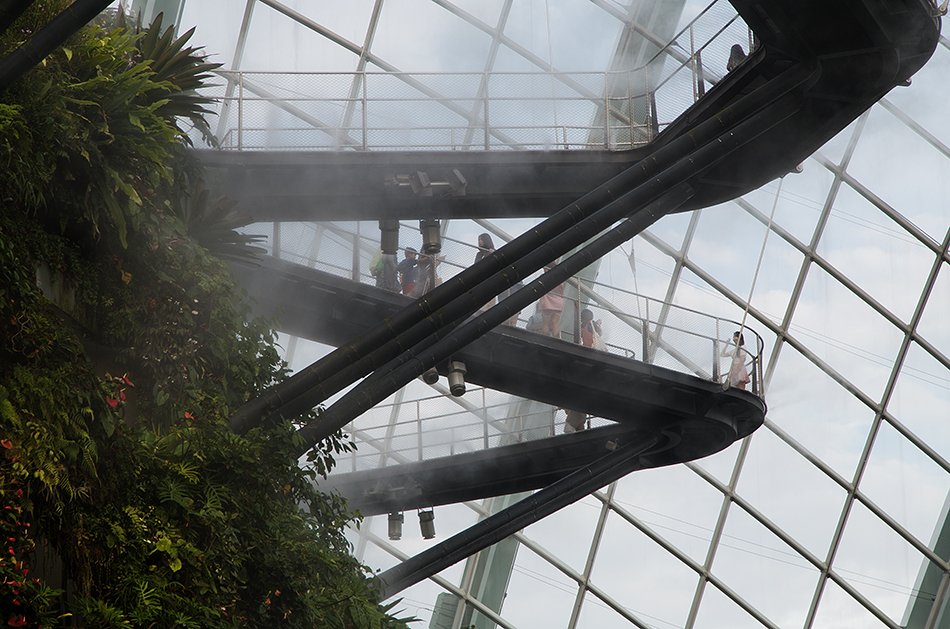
left=267, top=222, right=761, bottom=471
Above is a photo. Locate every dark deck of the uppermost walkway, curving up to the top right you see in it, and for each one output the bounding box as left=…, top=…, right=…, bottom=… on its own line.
left=196, top=0, right=939, bottom=221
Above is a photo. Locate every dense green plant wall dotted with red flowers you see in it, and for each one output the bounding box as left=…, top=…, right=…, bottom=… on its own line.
left=0, top=6, right=404, bottom=628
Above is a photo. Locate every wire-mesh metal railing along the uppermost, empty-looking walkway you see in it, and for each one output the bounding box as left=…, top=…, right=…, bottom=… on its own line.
left=205, top=0, right=751, bottom=151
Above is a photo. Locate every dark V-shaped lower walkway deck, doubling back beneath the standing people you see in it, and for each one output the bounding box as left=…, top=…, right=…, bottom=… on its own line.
left=234, top=258, right=765, bottom=515
